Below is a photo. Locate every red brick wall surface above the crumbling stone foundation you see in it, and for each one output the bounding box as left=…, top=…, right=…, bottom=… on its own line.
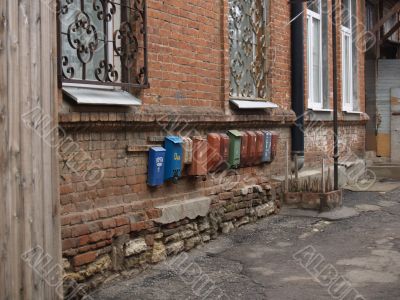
left=59, top=0, right=364, bottom=292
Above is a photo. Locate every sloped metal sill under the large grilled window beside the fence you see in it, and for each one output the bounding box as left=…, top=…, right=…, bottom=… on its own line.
left=63, top=87, right=142, bottom=106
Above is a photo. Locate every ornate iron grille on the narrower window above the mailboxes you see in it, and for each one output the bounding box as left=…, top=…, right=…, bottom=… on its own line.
left=229, top=0, right=267, bottom=99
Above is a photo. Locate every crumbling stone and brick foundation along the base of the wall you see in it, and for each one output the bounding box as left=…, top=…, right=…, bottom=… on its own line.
left=64, top=182, right=282, bottom=296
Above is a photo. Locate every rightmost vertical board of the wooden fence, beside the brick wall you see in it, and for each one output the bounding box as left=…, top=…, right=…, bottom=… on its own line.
left=40, top=1, right=62, bottom=299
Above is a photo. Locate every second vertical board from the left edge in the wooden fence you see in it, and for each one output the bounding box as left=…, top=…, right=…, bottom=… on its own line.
left=5, top=0, right=24, bottom=299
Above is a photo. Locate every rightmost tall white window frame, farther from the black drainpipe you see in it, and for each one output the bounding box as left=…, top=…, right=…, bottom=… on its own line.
left=341, top=0, right=355, bottom=112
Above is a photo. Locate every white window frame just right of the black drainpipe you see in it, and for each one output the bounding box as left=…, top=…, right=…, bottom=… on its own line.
left=307, top=1, right=324, bottom=109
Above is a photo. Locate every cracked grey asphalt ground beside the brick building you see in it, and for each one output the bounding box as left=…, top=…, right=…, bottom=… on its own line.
left=91, top=190, right=400, bottom=300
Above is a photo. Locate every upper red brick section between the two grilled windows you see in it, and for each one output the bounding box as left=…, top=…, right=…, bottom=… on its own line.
left=144, top=0, right=225, bottom=107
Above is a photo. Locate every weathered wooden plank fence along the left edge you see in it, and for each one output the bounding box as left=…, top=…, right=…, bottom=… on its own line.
left=0, top=0, right=62, bottom=299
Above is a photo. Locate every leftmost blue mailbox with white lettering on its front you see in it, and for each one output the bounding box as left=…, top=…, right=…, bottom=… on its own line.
left=147, top=147, right=165, bottom=186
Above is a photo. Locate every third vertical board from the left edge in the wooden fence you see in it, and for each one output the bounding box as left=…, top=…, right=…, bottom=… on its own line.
left=19, top=0, right=34, bottom=299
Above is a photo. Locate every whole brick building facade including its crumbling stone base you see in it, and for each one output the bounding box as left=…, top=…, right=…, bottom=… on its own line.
left=59, top=0, right=367, bottom=287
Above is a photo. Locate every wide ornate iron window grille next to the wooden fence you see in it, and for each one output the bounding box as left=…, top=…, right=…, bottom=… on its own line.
left=58, top=0, right=149, bottom=89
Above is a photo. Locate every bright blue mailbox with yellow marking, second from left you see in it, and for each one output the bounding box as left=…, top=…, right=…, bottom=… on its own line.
left=164, top=136, right=183, bottom=182
